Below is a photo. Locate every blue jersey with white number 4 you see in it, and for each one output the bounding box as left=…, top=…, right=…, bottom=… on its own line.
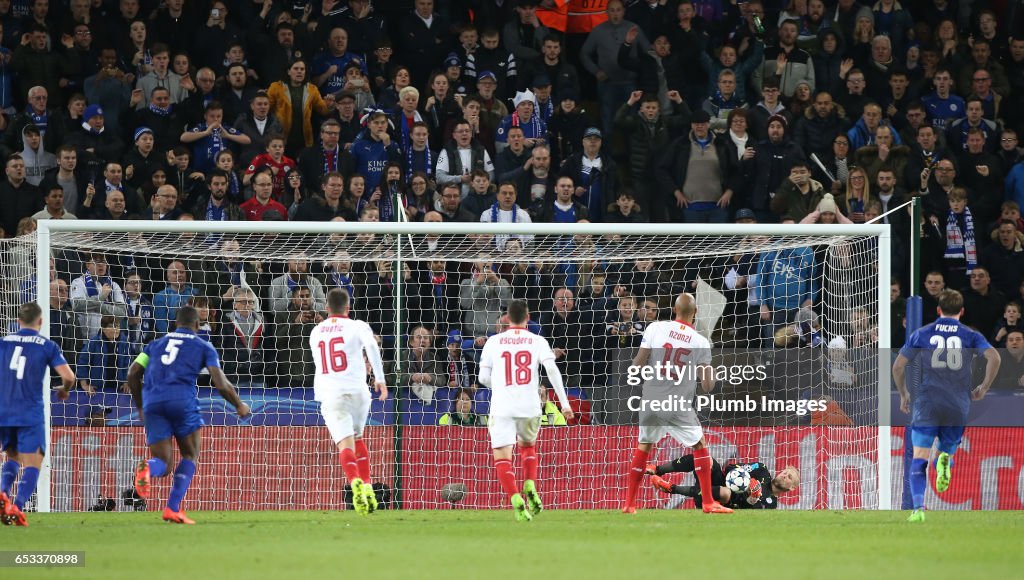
left=0, top=328, right=68, bottom=427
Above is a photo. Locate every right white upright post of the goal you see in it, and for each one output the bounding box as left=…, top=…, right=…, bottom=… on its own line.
left=878, top=225, right=892, bottom=509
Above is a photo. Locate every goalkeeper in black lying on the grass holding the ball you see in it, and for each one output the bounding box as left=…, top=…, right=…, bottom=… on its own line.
left=644, top=455, right=800, bottom=509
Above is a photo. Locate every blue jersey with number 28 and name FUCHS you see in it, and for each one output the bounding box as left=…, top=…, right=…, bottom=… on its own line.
left=900, top=317, right=992, bottom=426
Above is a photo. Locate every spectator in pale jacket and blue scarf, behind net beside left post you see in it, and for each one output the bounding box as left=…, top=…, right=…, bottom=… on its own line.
left=70, top=253, right=128, bottom=338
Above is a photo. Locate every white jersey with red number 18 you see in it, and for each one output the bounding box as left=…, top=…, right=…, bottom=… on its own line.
left=480, top=327, right=555, bottom=418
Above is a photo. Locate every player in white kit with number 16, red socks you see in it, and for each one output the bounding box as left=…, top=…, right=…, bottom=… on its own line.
left=309, top=288, right=387, bottom=515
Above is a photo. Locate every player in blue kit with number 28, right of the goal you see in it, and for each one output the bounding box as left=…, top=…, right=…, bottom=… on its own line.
left=893, top=290, right=999, bottom=522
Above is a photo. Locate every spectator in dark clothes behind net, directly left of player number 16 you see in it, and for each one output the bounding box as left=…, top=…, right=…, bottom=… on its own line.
left=273, top=286, right=326, bottom=387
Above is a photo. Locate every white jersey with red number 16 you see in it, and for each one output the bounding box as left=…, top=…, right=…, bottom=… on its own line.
left=309, top=317, right=384, bottom=402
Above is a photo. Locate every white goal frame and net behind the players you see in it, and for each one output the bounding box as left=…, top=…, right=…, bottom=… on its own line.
left=9, top=221, right=892, bottom=511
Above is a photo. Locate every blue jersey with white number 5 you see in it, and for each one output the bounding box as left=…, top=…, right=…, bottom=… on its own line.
left=142, top=328, right=220, bottom=407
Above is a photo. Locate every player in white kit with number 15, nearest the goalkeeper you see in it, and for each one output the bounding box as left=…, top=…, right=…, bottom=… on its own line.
left=623, top=294, right=732, bottom=513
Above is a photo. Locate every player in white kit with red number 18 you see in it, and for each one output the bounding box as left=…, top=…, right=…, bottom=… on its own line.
left=479, top=300, right=572, bottom=522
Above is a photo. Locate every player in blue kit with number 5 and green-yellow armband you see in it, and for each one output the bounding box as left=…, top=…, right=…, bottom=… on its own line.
left=128, top=306, right=249, bottom=524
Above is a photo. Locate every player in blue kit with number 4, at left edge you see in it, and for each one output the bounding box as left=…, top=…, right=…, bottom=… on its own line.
left=0, top=302, right=75, bottom=526
